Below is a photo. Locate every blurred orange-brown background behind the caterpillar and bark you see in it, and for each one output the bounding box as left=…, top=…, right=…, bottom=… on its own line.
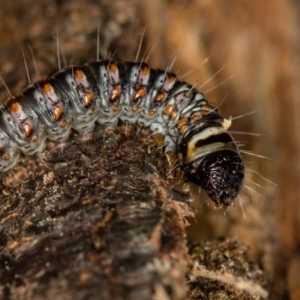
left=0, top=0, right=300, bottom=300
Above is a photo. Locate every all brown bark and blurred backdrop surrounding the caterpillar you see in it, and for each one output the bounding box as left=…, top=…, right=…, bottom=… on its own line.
left=0, top=0, right=300, bottom=300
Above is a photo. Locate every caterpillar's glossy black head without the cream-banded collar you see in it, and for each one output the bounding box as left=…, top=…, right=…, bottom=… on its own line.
left=184, top=150, right=244, bottom=208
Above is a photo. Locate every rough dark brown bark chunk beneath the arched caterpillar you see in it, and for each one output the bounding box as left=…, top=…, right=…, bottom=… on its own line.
left=0, top=126, right=193, bottom=299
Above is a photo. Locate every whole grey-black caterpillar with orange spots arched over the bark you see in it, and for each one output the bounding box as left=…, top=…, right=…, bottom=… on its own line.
left=0, top=60, right=244, bottom=207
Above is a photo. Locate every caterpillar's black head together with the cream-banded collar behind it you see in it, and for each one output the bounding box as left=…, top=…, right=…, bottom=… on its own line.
left=179, top=113, right=245, bottom=208
